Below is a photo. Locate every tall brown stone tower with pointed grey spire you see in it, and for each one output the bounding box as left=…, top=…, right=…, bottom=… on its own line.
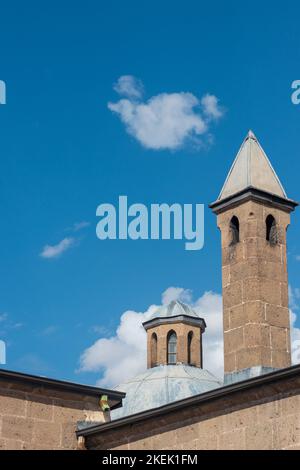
left=210, top=131, right=297, bottom=383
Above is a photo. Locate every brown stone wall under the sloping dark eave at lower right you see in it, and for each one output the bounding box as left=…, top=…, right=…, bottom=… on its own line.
left=86, top=372, right=300, bottom=450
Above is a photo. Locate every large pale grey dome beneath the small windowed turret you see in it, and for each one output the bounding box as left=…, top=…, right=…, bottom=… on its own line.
left=111, top=364, right=222, bottom=419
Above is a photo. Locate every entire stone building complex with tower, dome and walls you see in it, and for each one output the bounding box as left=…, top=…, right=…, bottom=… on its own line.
left=0, top=132, right=300, bottom=450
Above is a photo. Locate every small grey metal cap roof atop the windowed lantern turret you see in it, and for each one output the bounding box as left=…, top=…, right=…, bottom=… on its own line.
left=143, top=300, right=206, bottom=331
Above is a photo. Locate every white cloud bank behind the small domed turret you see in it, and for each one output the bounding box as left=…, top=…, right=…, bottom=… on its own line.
left=79, top=287, right=223, bottom=387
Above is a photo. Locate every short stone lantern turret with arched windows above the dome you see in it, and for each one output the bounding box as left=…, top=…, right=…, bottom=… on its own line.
left=143, top=301, right=206, bottom=369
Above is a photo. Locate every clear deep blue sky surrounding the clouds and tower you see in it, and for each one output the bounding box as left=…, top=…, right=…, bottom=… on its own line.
left=0, top=0, right=300, bottom=383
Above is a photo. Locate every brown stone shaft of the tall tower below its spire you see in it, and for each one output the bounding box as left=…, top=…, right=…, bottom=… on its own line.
left=218, top=201, right=291, bottom=373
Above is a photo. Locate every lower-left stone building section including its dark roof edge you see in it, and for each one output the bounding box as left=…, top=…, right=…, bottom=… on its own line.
left=0, top=370, right=124, bottom=450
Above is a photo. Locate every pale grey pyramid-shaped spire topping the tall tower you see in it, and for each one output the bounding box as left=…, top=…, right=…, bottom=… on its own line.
left=218, top=130, right=287, bottom=201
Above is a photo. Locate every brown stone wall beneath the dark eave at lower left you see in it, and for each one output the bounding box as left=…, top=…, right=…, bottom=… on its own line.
left=0, top=380, right=104, bottom=450
